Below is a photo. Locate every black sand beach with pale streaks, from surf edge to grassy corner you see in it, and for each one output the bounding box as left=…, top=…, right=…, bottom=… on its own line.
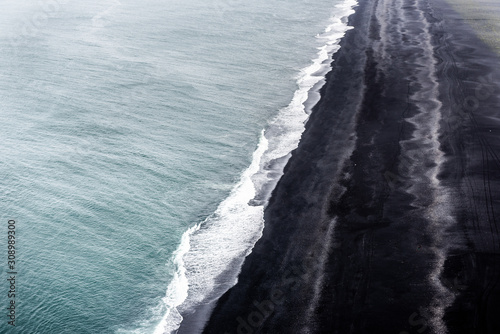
left=184, top=0, right=500, bottom=334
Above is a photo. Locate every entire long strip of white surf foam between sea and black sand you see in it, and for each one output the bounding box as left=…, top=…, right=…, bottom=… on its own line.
left=154, top=0, right=357, bottom=334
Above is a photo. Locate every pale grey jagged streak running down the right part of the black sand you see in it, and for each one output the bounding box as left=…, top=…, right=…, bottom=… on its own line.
left=398, top=1, right=456, bottom=333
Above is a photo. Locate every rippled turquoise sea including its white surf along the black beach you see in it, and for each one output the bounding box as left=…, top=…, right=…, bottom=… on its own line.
left=0, top=0, right=353, bottom=333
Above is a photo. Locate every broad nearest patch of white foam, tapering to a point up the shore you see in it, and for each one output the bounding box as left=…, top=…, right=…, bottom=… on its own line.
left=154, top=133, right=268, bottom=334
